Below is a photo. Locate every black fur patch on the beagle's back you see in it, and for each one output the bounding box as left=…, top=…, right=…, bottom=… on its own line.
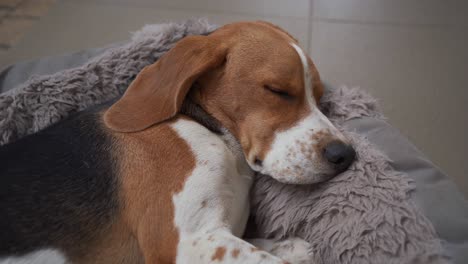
left=0, top=105, right=118, bottom=256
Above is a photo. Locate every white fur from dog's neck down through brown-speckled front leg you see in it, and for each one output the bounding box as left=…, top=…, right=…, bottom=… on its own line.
left=172, top=120, right=302, bottom=264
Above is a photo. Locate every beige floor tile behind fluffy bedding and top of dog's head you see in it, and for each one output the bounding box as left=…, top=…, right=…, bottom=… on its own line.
left=2, top=1, right=308, bottom=65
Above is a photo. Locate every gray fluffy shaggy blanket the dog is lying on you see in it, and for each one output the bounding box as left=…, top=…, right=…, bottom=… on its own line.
left=0, top=20, right=448, bottom=263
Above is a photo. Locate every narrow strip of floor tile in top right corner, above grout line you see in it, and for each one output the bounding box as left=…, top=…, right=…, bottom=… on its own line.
left=312, top=0, right=468, bottom=28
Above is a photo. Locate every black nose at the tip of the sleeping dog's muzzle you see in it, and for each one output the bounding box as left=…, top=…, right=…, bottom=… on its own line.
left=323, top=140, right=356, bottom=173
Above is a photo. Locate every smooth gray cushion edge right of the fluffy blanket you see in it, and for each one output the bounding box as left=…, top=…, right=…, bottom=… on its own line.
left=346, top=118, right=468, bottom=263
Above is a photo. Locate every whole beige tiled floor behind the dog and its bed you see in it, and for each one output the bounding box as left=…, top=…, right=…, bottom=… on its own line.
left=0, top=0, right=468, bottom=194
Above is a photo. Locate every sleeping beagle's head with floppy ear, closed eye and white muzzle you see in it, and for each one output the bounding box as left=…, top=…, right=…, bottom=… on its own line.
left=104, top=22, right=355, bottom=184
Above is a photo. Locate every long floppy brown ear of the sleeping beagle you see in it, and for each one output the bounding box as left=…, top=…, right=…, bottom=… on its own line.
left=104, top=36, right=227, bottom=132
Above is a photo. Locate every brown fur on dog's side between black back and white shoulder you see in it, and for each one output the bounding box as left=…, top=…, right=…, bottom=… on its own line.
left=110, top=117, right=195, bottom=263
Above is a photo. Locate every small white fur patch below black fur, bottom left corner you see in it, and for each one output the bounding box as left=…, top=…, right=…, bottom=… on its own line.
left=0, top=249, right=67, bottom=264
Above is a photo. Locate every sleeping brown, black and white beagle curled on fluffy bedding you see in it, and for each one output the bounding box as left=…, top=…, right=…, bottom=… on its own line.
left=0, top=22, right=355, bottom=264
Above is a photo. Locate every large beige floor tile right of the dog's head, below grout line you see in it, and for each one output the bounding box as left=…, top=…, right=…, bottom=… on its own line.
left=311, top=21, right=468, bottom=194
